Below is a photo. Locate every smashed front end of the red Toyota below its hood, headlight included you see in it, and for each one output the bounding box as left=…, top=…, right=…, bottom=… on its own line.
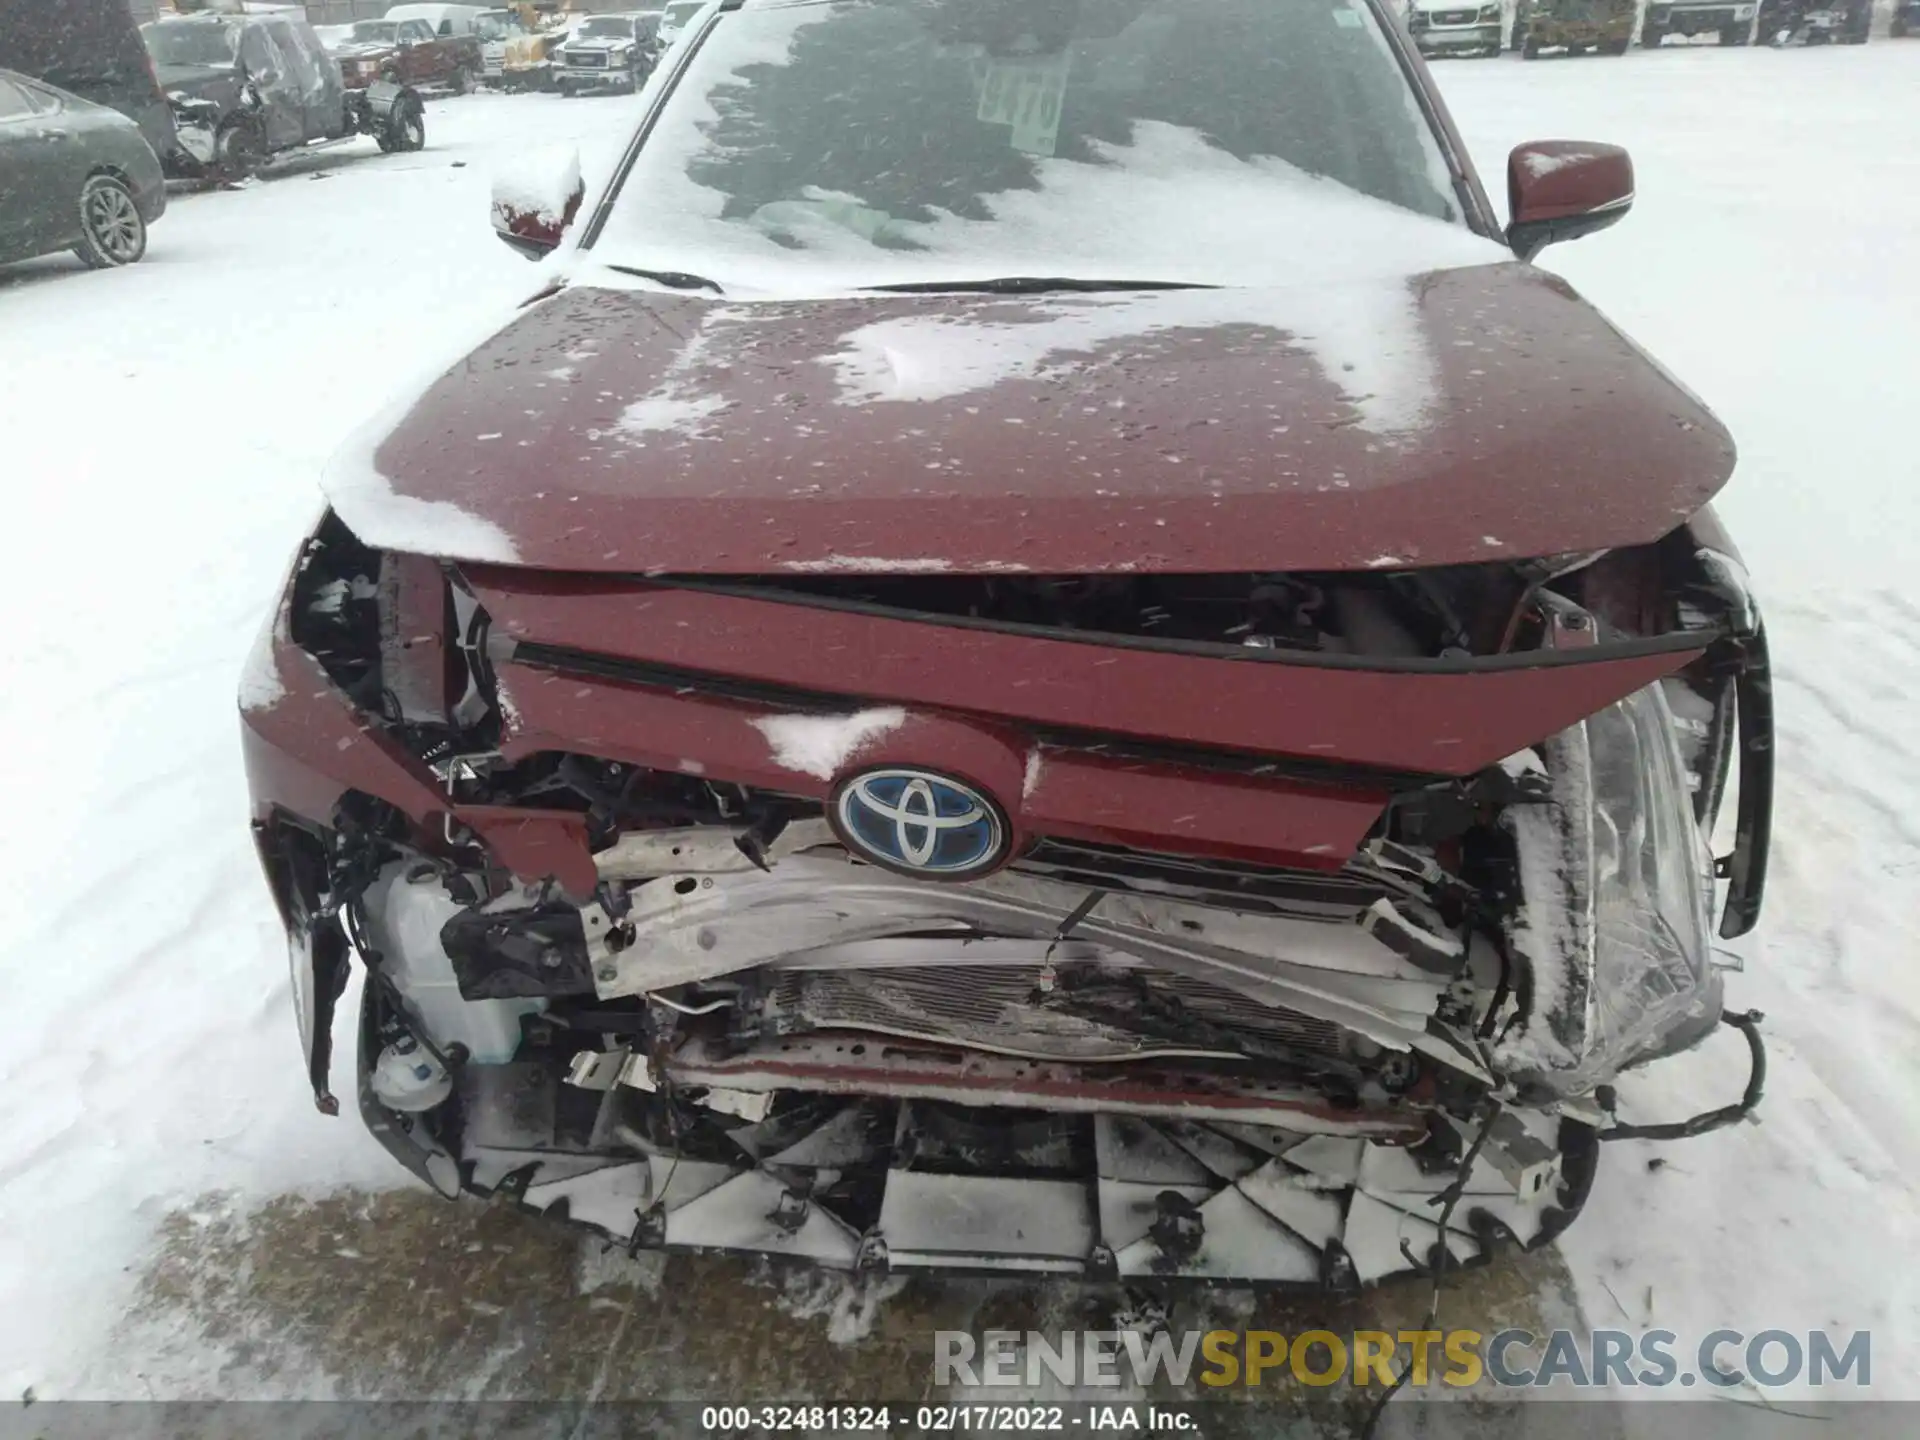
left=244, top=518, right=1770, bottom=1284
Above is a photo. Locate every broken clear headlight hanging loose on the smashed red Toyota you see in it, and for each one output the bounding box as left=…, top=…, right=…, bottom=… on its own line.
left=1496, top=685, right=1720, bottom=1094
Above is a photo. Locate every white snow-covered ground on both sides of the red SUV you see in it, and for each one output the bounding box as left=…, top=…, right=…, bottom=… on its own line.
left=0, top=48, right=1920, bottom=1396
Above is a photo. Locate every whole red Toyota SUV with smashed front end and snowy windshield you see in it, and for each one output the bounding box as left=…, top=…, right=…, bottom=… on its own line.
left=242, top=0, right=1772, bottom=1286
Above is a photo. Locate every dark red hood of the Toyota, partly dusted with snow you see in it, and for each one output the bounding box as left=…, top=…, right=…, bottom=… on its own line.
left=326, top=263, right=1734, bottom=574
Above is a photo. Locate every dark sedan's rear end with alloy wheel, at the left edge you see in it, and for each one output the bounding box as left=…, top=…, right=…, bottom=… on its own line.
left=0, top=69, right=167, bottom=271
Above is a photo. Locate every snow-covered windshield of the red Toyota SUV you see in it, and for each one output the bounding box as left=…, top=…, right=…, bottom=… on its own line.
left=595, top=0, right=1484, bottom=288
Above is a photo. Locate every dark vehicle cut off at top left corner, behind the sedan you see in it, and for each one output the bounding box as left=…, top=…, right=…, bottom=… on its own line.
left=0, top=0, right=175, bottom=159
